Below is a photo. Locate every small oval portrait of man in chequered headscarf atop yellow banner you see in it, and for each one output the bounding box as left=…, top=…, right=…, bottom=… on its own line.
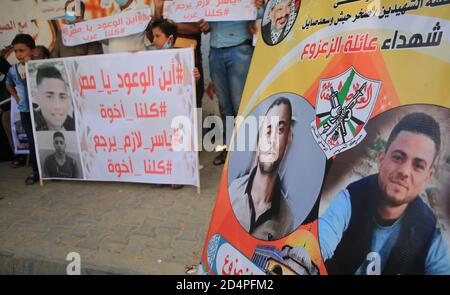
left=261, top=0, right=301, bottom=45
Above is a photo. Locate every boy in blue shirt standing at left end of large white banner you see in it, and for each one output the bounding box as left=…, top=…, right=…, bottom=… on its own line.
left=6, top=34, right=39, bottom=184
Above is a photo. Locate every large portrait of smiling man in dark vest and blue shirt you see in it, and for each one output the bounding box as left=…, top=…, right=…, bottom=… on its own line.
left=318, top=104, right=450, bottom=275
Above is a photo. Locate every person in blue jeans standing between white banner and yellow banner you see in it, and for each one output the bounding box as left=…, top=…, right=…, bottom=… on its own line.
left=198, top=0, right=264, bottom=165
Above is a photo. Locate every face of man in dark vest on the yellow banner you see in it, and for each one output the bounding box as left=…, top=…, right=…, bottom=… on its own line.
left=378, top=131, right=435, bottom=207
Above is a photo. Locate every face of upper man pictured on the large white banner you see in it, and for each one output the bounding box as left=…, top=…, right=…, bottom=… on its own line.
left=37, top=78, right=69, bottom=130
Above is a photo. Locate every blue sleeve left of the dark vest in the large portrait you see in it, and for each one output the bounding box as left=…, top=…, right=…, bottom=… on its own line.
left=319, top=189, right=352, bottom=261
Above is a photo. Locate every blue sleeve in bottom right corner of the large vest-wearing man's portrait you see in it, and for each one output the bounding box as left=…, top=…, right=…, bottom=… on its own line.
left=425, top=229, right=450, bottom=275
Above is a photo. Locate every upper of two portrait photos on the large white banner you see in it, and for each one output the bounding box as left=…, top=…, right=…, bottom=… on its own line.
left=28, top=60, right=75, bottom=131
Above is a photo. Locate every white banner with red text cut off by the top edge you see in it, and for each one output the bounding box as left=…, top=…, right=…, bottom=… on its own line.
left=164, top=0, right=256, bottom=23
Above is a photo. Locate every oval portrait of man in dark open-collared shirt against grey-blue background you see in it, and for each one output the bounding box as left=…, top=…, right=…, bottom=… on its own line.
left=228, top=93, right=326, bottom=241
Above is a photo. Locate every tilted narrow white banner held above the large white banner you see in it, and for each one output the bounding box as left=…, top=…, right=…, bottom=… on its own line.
left=62, top=8, right=151, bottom=46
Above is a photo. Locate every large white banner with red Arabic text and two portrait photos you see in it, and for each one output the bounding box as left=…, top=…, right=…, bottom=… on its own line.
left=27, top=48, right=199, bottom=186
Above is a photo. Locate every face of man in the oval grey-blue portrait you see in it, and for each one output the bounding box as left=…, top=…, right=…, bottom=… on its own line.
left=258, top=104, right=291, bottom=173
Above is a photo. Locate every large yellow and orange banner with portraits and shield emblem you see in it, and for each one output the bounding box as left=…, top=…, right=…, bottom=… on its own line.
left=200, top=0, right=450, bottom=275
